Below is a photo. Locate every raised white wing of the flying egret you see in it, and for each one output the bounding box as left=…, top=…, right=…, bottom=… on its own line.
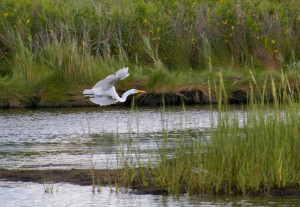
left=93, top=67, right=129, bottom=88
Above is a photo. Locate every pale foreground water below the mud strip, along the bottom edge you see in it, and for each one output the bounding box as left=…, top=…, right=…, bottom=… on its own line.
left=0, top=181, right=300, bottom=207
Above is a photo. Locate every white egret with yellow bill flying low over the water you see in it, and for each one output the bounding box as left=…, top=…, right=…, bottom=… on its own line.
left=68, top=67, right=146, bottom=106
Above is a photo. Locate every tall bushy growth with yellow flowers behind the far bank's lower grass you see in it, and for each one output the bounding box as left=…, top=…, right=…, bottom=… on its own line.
left=0, top=0, right=300, bottom=68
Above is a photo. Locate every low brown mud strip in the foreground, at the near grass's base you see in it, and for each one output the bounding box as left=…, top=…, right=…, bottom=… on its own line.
left=0, top=169, right=300, bottom=196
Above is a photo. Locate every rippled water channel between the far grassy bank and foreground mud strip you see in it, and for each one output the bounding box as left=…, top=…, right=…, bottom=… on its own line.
left=0, top=108, right=217, bottom=169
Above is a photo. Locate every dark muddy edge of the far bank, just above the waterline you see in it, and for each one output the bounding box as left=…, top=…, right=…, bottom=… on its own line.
left=0, top=88, right=248, bottom=109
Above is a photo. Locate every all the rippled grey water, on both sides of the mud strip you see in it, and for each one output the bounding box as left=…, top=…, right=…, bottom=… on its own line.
left=0, top=106, right=300, bottom=207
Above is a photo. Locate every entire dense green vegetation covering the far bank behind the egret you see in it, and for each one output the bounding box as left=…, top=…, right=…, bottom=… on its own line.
left=0, top=0, right=300, bottom=107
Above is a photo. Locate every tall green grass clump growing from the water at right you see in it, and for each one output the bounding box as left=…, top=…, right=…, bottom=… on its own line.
left=115, top=75, right=300, bottom=195
